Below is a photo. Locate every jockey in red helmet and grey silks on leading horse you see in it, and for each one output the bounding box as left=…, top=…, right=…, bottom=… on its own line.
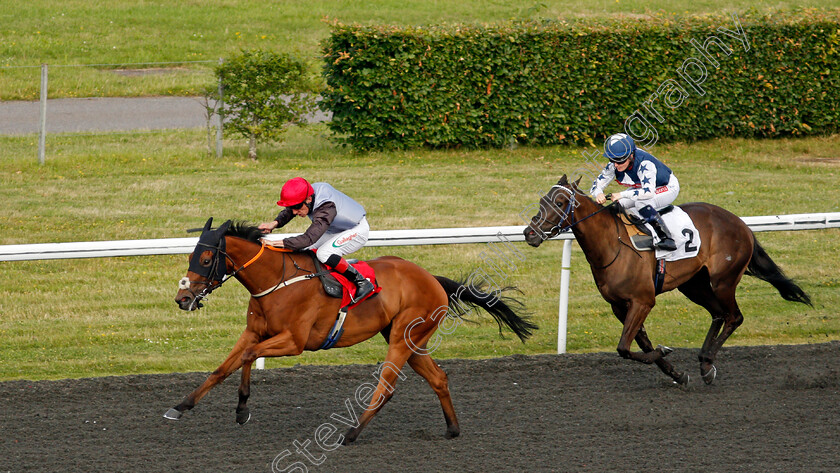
left=259, top=177, right=374, bottom=301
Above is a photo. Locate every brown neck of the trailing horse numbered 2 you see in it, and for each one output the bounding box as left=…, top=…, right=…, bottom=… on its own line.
left=572, top=196, right=619, bottom=266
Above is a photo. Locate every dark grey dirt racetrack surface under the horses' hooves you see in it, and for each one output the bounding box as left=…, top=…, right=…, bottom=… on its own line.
left=0, top=342, right=840, bottom=473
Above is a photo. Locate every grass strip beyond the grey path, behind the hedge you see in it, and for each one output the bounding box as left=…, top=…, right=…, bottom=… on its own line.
left=0, top=0, right=840, bottom=100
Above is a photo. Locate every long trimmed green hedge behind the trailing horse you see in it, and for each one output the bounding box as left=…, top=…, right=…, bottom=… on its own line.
left=321, top=9, right=840, bottom=150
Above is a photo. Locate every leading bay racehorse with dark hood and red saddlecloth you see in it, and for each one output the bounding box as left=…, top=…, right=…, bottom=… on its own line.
left=164, top=218, right=537, bottom=444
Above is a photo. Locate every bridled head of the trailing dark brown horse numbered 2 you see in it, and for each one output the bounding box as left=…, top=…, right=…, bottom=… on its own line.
left=524, top=174, right=580, bottom=247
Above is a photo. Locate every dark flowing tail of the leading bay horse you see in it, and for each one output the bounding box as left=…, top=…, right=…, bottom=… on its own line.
left=435, top=276, right=539, bottom=343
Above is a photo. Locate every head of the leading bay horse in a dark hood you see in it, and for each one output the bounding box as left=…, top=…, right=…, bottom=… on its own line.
left=175, top=217, right=231, bottom=310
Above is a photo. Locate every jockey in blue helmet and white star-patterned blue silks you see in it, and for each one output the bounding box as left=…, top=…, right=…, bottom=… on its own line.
left=589, top=133, right=680, bottom=251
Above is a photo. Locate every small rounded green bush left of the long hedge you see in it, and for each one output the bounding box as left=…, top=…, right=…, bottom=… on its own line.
left=215, top=50, right=316, bottom=159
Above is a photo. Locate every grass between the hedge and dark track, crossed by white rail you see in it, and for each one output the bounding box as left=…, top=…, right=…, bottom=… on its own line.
left=0, top=126, right=840, bottom=379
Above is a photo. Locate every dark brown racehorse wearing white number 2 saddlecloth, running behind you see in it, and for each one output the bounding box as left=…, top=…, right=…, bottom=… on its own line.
left=524, top=175, right=811, bottom=384
